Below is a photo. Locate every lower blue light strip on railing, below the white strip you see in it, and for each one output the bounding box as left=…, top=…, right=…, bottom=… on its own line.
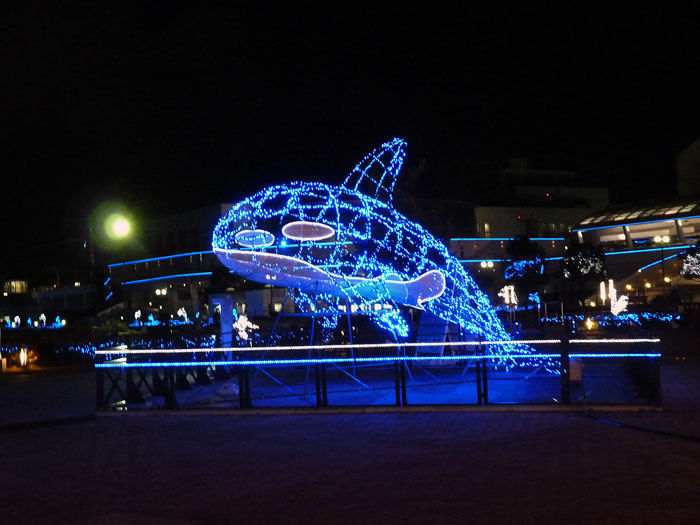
left=95, top=353, right=661, bottom=368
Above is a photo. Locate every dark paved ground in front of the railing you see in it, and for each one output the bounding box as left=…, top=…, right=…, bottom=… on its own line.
left=0, top=361, right=700, bottom=523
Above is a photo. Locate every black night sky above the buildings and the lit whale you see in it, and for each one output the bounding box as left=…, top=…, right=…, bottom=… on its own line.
left=0, top=2, right=700, bottom=270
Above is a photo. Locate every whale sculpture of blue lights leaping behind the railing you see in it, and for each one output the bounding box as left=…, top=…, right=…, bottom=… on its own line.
left=212, top=139, right=532, bottom=364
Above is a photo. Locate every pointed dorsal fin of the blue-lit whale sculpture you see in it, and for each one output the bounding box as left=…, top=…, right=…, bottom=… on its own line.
left=343, top=138, right=406, bottom=204
